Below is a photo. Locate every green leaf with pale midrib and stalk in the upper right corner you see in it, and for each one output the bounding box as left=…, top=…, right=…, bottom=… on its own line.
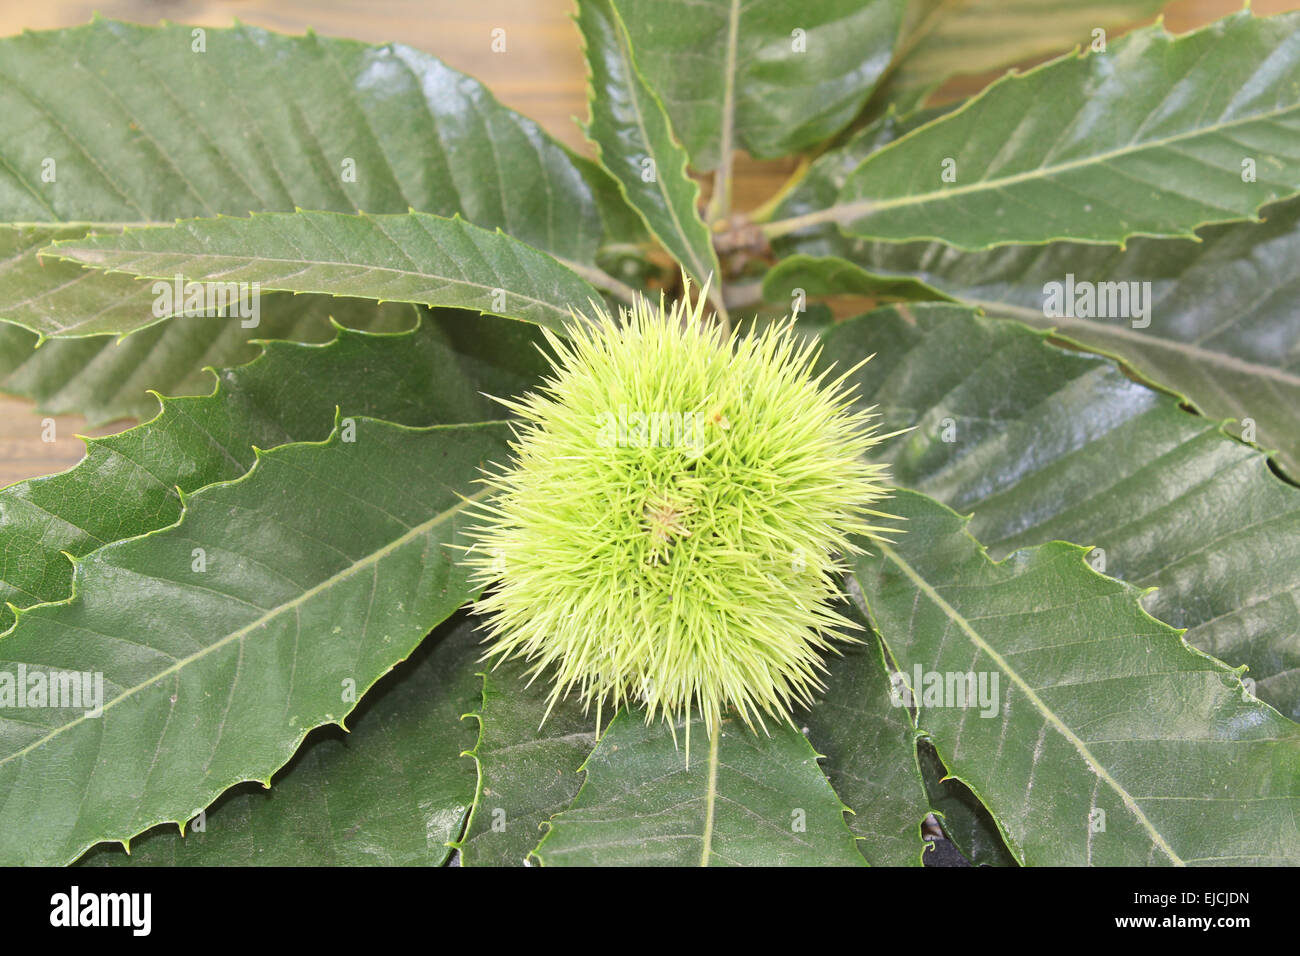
left=795, top=12, right=1300, bottom=250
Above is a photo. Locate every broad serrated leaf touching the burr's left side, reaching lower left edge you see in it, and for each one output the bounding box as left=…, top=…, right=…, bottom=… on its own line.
left=0, top=419, right=510, bottom=864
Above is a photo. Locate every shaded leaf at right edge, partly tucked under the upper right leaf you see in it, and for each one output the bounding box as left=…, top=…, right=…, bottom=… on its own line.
left=790, top=200, right=1300, bottom=475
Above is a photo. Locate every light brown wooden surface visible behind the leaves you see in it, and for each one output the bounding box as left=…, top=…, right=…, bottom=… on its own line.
left=0, top=0, right=1300, bottom=486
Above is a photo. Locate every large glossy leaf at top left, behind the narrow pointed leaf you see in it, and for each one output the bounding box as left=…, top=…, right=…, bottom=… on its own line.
left=0, top=20, right=618, bottom=336
